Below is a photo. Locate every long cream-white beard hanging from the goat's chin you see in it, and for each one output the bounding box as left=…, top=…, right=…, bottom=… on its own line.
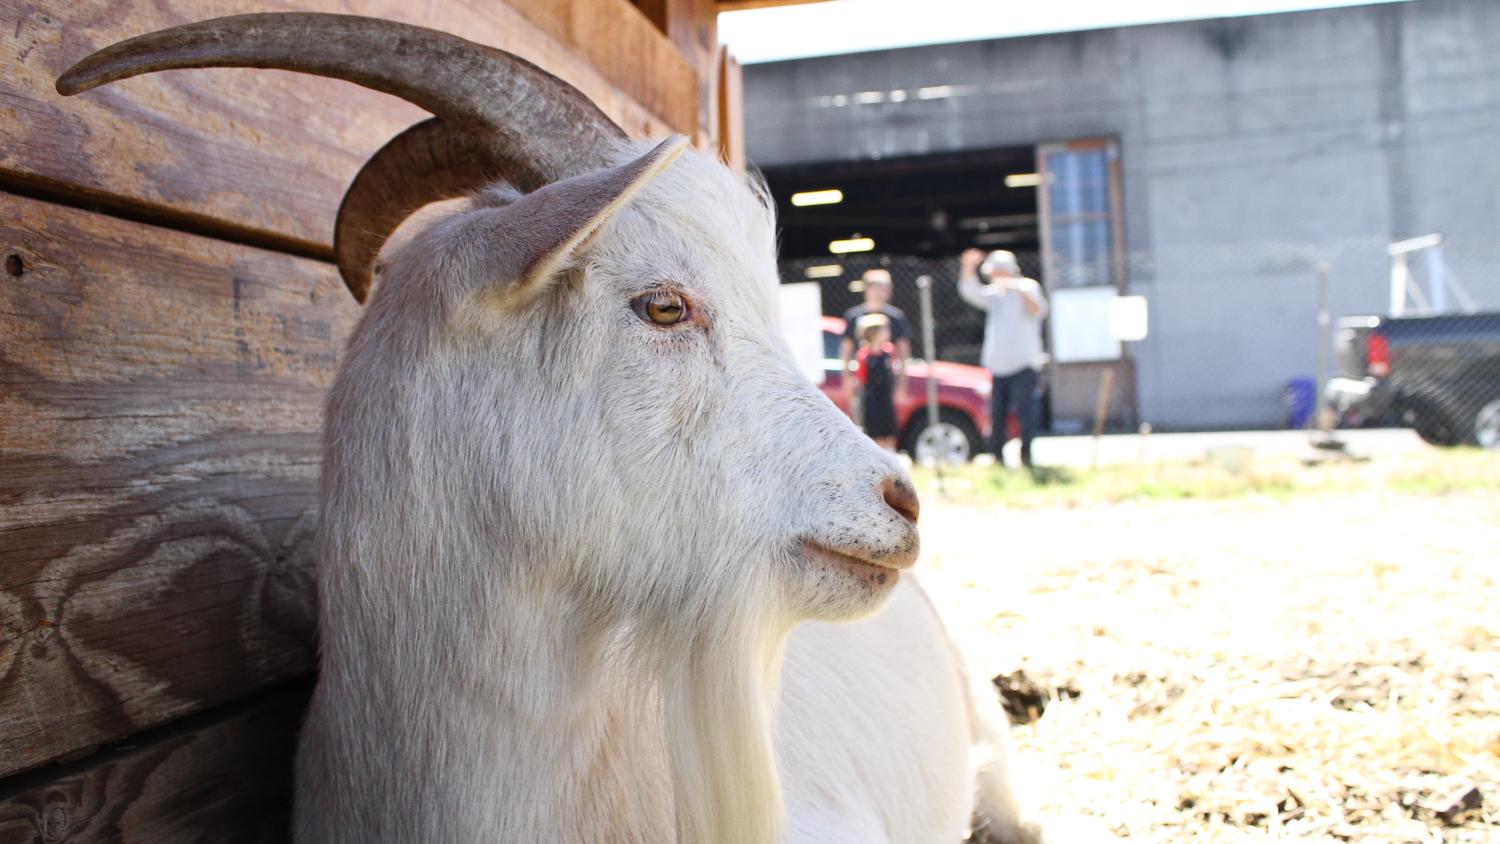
left=657, top=575, right=792, bottom=844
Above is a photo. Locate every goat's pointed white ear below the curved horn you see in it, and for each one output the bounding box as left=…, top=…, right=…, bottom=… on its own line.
left=480, top=135, right=687, bottom=304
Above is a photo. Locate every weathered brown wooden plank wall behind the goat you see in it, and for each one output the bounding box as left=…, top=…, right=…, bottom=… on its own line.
left=0, top=0, right=738, bottom=844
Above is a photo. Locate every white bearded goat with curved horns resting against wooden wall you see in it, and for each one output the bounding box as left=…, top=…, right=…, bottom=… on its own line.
left=59, top=15, right=1029, bottom=844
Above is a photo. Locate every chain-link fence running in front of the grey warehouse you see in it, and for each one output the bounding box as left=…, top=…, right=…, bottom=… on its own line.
left=780, top=238, right=1500, bottom=454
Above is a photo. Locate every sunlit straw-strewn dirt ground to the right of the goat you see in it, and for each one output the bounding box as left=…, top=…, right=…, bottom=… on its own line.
left=918, top=468, right=1500, bottom=843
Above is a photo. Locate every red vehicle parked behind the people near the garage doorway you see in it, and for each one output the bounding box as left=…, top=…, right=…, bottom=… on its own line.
left=822, top=316, right=990, bottom=462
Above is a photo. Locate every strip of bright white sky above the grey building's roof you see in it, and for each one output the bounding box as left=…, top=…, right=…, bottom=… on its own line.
left=719, top=0, right=1409, bottom=64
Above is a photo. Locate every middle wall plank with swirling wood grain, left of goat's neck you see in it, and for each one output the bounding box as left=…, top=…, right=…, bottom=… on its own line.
left=0, top=195, right=357, bottom=775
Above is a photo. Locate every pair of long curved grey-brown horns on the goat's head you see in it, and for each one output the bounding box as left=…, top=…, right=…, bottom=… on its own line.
left=57, top=12, right=624, bottom=301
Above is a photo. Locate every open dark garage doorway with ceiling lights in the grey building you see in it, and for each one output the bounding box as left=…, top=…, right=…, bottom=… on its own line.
left=764, top=139, right=1137, bottom=433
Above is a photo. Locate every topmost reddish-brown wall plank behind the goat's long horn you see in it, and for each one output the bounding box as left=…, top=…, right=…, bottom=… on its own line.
left=0, top=0, right=684, bottom=256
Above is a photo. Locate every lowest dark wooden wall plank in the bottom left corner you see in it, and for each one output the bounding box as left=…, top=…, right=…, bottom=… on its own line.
left=0, top=684, right=311, bottom=844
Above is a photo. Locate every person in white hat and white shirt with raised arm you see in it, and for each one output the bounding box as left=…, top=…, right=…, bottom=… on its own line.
left=959, top=249, right=1047, bottom=468
